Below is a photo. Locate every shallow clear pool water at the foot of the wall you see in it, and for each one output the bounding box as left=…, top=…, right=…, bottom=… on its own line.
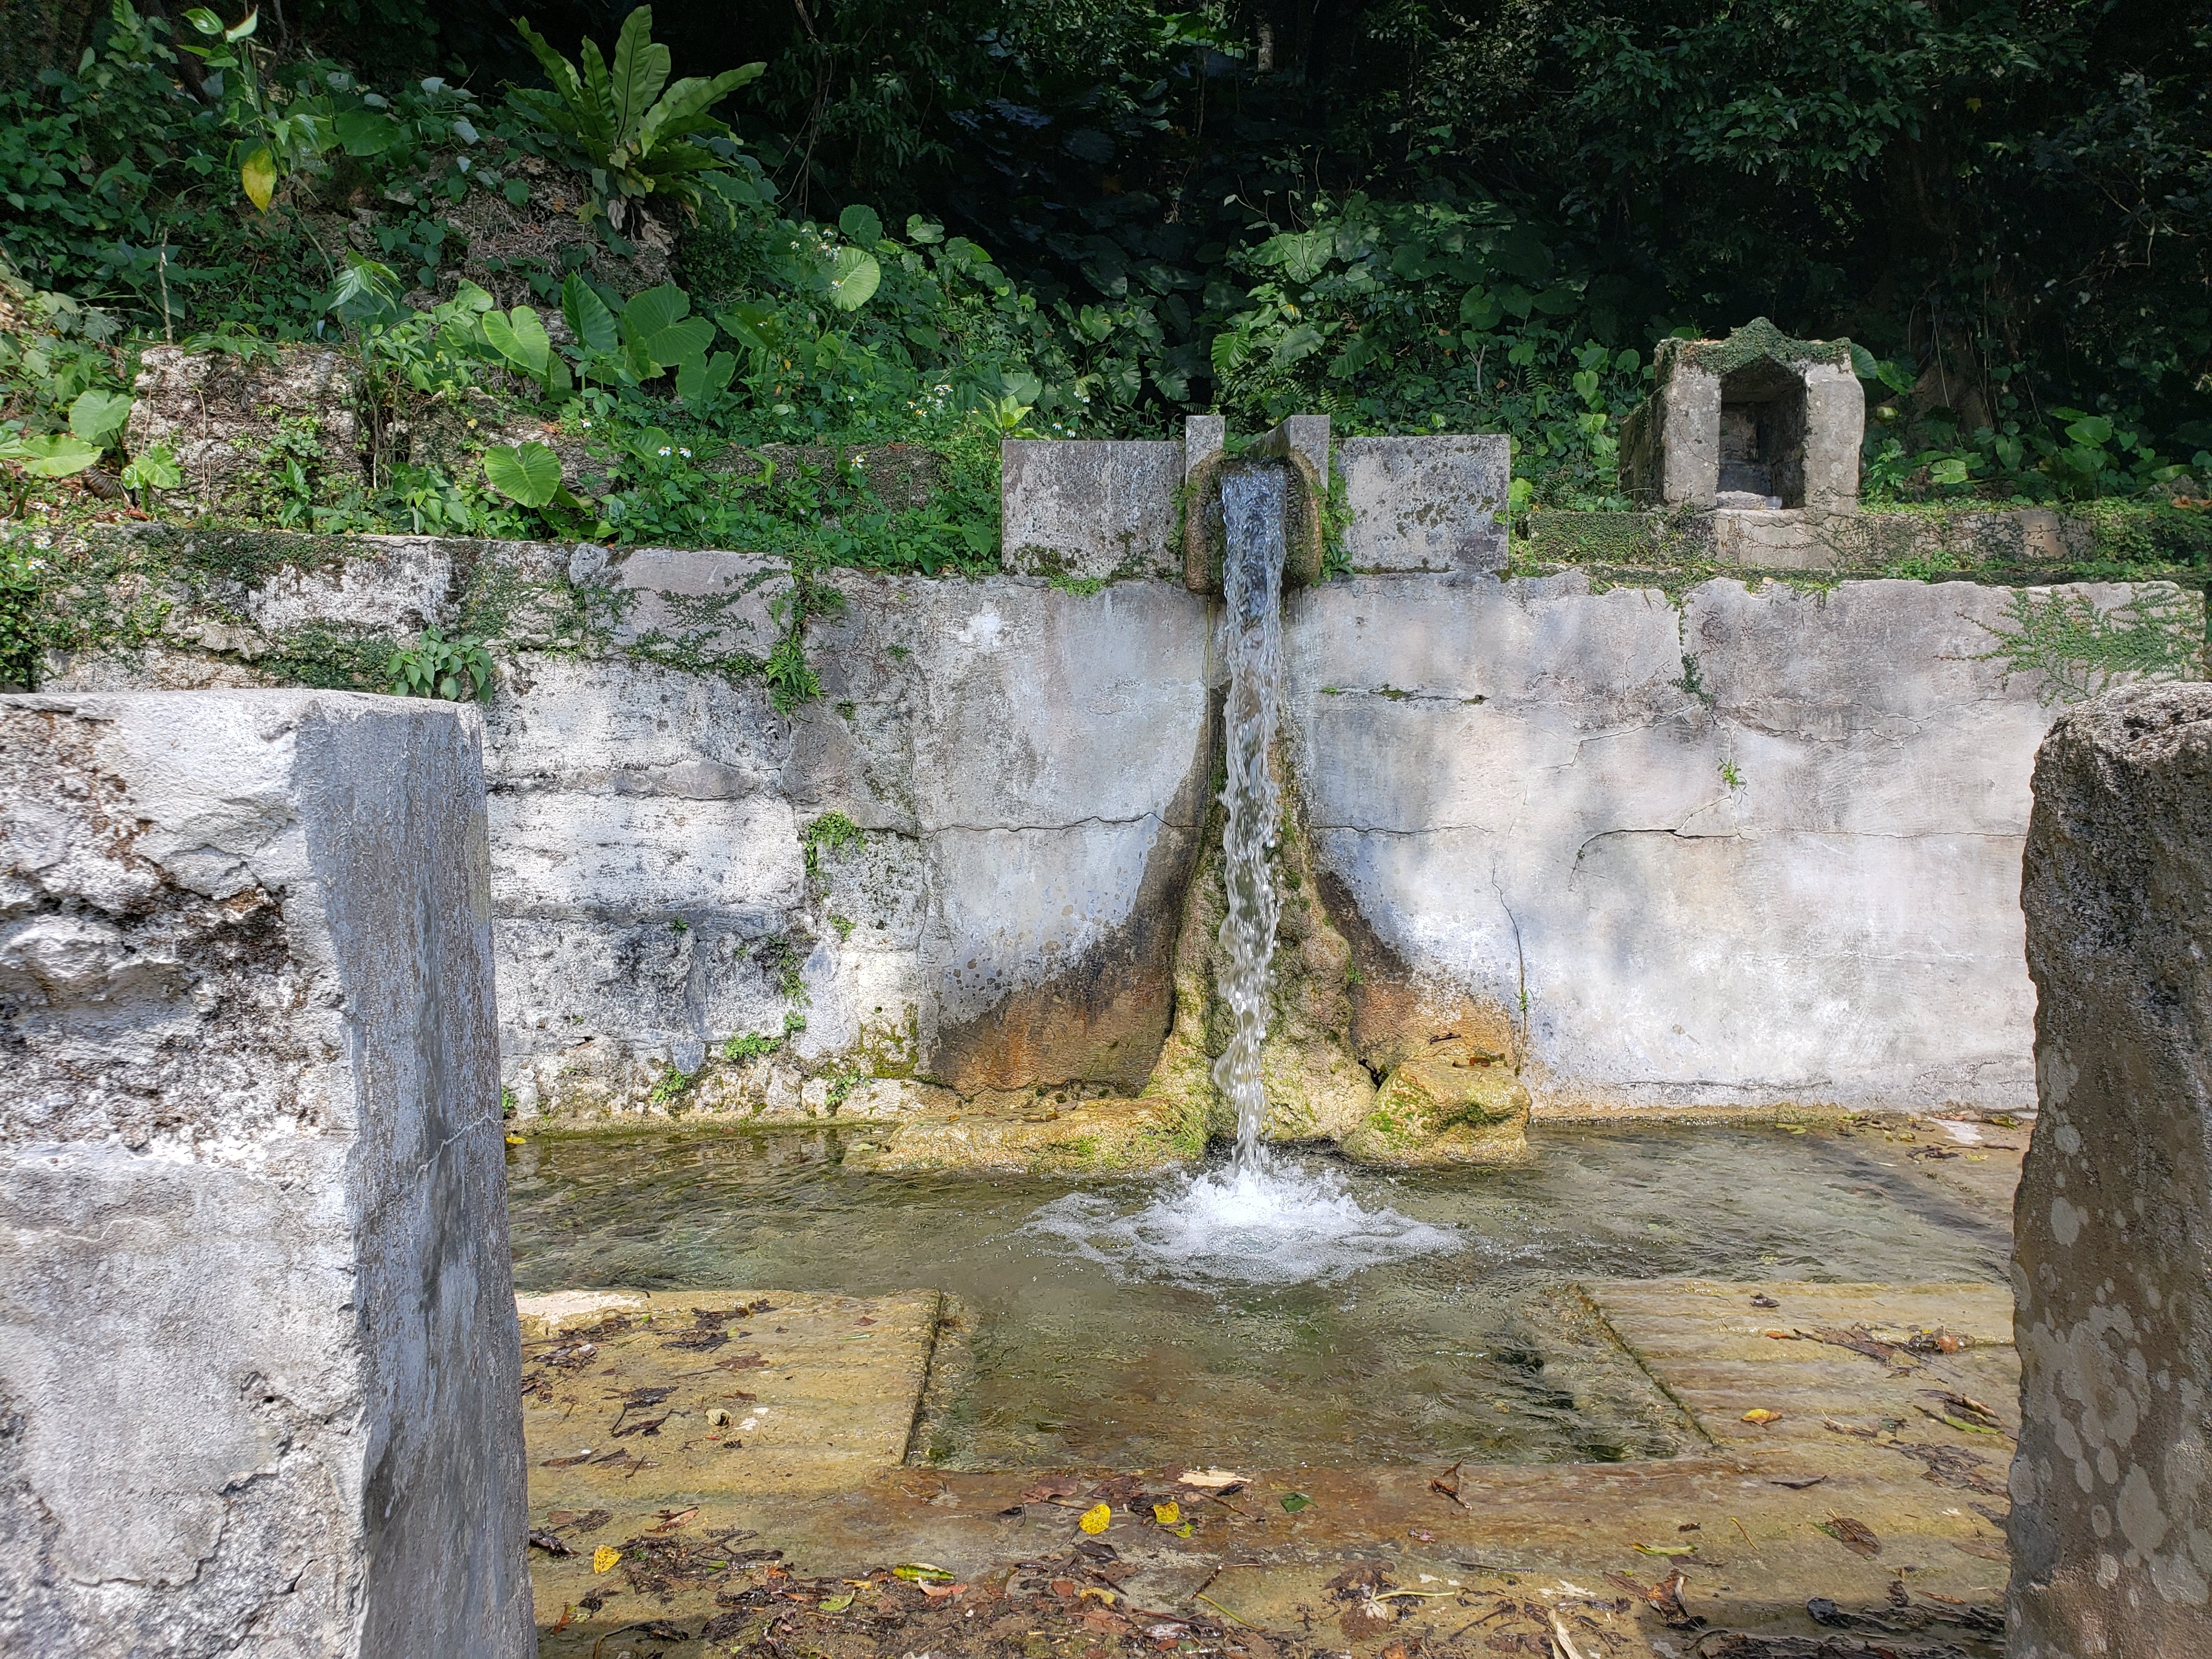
left=509, top=1128, right=2008, bottom=1469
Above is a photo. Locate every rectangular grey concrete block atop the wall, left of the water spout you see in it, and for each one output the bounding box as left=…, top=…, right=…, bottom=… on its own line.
left=1000, top=438, right=1183, bottom=579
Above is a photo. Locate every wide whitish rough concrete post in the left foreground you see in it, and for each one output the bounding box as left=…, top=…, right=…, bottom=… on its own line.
left=0, top=690, right=535, bottom=1659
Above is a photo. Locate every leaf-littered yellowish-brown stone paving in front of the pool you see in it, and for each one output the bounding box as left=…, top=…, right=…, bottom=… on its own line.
left=531, top=1281, right=2013, bottom=1659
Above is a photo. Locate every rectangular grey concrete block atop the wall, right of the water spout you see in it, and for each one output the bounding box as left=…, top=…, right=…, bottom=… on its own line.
left=1336, top=433, right=1509, bottom=573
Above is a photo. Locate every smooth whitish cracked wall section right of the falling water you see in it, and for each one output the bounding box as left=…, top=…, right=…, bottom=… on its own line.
left=1285, top=575, right=2185, bottom=1110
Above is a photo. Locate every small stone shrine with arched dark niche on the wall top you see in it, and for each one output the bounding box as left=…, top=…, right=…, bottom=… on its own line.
left=1621, top=317, right=1867, bottom=513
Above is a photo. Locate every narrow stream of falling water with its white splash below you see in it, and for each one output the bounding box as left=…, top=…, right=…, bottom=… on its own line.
left=1024, top=460, right=1464, bottom=1285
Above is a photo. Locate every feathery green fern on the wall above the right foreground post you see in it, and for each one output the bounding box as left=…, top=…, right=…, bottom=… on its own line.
left=1976, top=584, right=2205, bottom=708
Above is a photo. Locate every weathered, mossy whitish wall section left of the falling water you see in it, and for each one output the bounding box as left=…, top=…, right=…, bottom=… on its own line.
left=487, top=555, right=1212, bottom=1117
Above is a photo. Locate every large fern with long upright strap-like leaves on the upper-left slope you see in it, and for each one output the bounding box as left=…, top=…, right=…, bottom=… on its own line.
left=506, top=7, right=768, bottom=230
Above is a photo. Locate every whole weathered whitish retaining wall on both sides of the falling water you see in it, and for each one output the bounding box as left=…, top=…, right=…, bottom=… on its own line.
left=35, top=544, right=2194, bottom=1121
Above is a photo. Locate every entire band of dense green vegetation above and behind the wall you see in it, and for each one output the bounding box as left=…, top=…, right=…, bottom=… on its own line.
left=0, top=0, right=2212, bottom=560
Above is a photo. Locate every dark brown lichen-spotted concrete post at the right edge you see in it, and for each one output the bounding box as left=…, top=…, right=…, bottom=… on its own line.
left=2008, top=686, right=2212, bottom=1659
